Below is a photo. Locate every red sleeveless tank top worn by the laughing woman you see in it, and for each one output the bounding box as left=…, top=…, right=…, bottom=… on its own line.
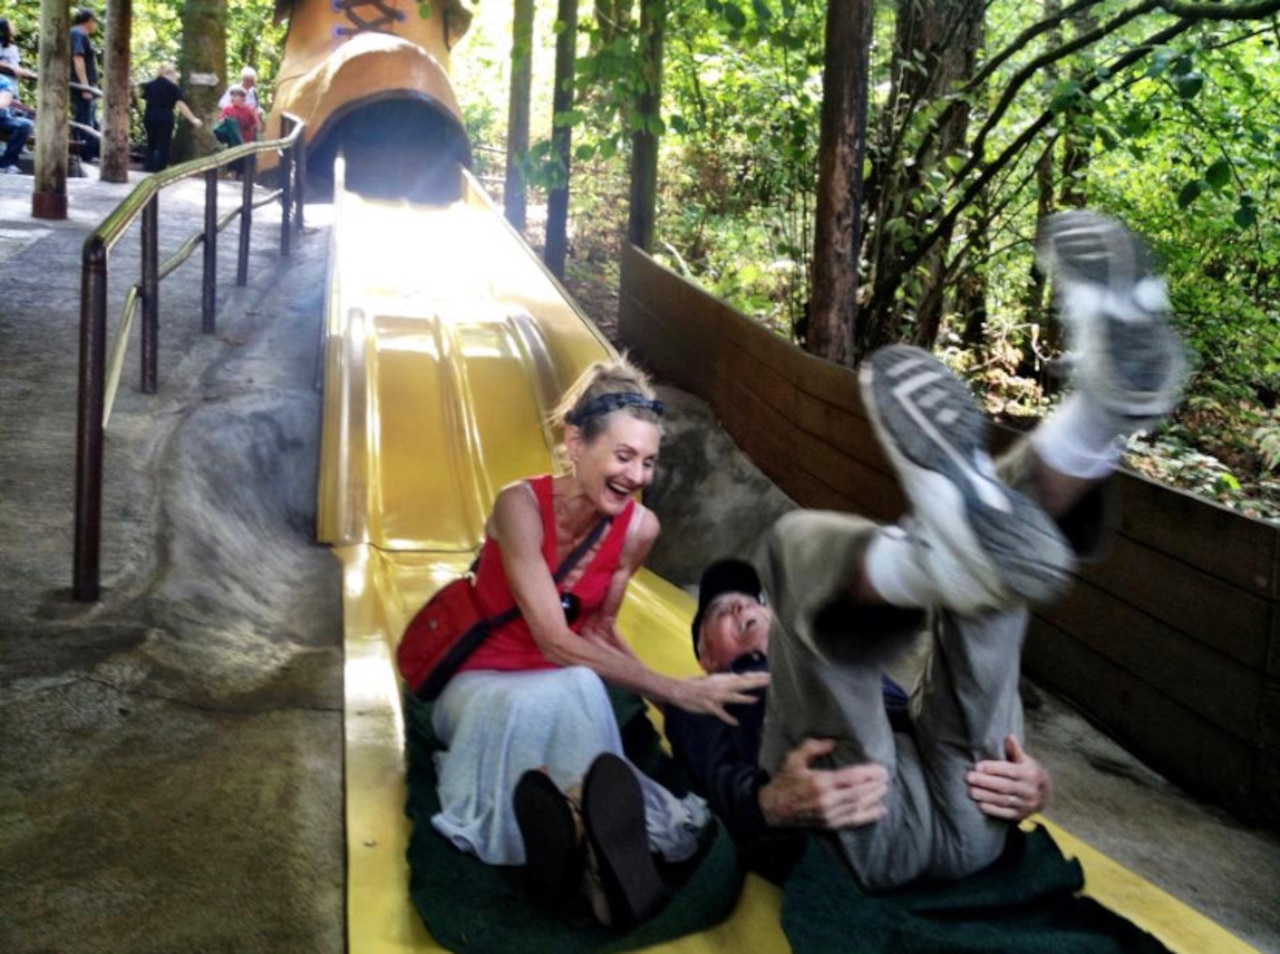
left=458, top=474, right=636, bottom=672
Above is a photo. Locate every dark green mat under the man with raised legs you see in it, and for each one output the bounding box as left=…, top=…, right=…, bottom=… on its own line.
left=782, top=829, right=1167, bottom=954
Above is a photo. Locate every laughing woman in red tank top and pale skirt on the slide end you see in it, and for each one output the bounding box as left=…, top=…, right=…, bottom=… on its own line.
left=431, top=360, right=767, bottom=926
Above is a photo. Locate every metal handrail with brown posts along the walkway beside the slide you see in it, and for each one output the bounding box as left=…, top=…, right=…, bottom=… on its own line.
left=72, top=114, right=306, bottom=602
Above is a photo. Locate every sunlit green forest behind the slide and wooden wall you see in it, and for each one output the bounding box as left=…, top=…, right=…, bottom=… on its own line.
left=4, top=0, right=1280, bottom=521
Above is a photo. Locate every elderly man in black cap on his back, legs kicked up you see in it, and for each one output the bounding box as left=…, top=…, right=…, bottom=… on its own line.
left=667, top=211, right=1184, bottom=890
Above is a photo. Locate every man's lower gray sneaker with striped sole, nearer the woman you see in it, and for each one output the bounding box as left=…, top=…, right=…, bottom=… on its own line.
left=859, top=344, right=1074, bottom=613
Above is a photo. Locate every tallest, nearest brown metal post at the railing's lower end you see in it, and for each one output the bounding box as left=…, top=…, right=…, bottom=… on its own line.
left=72, top=238, right=106, bottom=594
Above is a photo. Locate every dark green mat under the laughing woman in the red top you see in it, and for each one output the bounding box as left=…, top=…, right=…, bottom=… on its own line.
left=404, top=695, right=742, bottom=954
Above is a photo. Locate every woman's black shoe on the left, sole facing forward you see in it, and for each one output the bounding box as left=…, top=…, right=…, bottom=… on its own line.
left=512, top=770, right=582, bottom=907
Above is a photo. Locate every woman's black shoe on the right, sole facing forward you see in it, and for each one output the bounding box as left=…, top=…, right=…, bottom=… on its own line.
left=582, top=753, right=667, bottom=931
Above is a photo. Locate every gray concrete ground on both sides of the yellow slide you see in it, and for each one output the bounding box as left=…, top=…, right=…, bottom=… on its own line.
left=0, top=177, right=1280, bottom=954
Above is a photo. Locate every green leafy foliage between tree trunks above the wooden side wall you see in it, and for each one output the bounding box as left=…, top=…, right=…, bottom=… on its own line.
left=453, top=0, right=1280, bottom=512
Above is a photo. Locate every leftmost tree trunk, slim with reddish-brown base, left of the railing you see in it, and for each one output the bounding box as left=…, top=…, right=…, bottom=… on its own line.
left=31, top=0, right=72, bottom=219
